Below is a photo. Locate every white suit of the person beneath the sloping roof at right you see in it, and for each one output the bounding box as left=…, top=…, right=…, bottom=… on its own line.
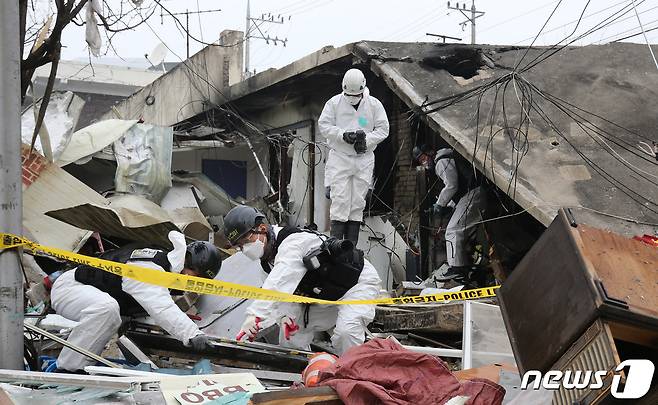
left=434, top=148, right=485, bottom=267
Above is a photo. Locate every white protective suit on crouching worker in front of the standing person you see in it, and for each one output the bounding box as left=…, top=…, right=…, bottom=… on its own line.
left=246, top=226, right=381, bottom=354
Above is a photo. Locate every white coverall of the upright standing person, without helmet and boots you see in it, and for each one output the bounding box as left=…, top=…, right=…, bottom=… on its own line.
left=318, top=87, right=388, bottom=222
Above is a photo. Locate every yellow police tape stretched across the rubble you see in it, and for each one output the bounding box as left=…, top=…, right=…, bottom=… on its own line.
left=0, top=233, right=499, bottom=305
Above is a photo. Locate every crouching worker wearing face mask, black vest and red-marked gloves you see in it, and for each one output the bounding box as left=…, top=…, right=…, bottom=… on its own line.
left=224, top=206, right=381, bottom=354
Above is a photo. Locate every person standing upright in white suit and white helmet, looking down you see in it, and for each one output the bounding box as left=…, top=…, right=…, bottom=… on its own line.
left=318, top=69, right=389, bottom=245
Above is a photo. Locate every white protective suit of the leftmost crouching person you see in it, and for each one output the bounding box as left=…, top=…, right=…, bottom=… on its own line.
left=50, top=231, right=203, bottom=371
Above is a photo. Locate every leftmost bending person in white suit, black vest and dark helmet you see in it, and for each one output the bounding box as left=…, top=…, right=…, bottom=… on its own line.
left=50, top=231, right=222, bottom=372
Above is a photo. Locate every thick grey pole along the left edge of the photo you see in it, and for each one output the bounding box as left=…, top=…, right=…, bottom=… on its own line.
left=0, top=0, right=24, bottom=370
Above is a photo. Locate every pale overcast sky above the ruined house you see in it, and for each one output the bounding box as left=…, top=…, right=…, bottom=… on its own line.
left=55, top=0, right=658, bottom=71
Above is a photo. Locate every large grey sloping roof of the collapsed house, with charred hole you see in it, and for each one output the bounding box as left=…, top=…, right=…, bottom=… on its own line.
left=111, top=41, right=658, bottom=235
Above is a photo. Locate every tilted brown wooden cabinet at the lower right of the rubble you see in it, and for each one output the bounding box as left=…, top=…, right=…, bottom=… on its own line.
left=499, top=210, right=658, bottom=403
